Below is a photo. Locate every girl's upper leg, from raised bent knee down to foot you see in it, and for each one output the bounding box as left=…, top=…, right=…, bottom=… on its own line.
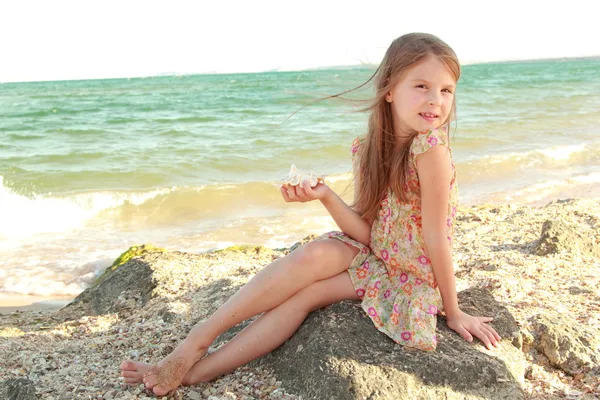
left=121, top=239, right=358, bottom=395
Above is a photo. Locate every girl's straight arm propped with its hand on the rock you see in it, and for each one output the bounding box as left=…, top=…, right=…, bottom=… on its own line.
left=417, top=146, right=500, bottom=349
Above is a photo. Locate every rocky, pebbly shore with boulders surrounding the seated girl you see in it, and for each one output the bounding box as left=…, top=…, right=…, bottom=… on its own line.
left=0, top=199, right=600, bottom=400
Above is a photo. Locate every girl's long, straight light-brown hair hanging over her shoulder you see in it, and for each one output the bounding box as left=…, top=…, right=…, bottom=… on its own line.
left=353, top=33, right=460, bottom=221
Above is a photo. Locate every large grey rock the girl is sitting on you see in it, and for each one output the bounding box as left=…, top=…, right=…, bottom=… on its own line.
left=255, top=290, right=524, bottom=400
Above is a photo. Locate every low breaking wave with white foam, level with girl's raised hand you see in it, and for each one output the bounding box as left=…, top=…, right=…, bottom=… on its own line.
left=0, top=174, right=349, bottom=238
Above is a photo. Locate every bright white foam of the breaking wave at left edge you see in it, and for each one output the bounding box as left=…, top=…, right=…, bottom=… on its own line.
left=0, top=176, right=172, bottom=238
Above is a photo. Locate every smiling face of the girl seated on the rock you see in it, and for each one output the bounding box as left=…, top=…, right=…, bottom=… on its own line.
left=385, top=55, right=456, bottom=136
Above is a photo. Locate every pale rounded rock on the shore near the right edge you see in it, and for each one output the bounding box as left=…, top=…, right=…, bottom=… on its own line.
left=535, top=219, right=600, bottom=257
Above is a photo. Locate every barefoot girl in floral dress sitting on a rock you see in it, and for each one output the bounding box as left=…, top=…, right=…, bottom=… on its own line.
left=121, top=33, right=500, bottom=395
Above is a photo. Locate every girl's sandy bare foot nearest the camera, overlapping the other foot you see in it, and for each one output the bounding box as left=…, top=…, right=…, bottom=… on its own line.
left=142, top=347, right=207, bottom=396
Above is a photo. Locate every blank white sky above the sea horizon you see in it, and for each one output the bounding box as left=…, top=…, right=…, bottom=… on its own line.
left=0, top=0, right=600, bottom=82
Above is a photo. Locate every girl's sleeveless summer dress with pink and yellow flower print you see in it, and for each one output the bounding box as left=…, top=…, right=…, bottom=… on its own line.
left=318, top=129, right=458, bottom=350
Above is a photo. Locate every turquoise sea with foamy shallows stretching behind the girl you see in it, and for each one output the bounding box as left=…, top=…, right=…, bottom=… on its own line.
left=0, top=59, right=600, bottom=295
